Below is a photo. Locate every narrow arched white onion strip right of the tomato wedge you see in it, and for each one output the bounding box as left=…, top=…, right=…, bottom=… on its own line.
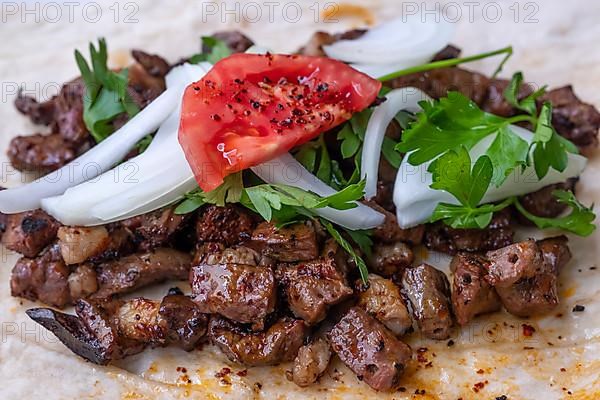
left=360, top=87, right=431, bottom=199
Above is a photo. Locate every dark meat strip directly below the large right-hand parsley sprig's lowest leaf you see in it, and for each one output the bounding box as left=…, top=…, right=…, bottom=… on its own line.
left=424, top=211, right=514, bottom=254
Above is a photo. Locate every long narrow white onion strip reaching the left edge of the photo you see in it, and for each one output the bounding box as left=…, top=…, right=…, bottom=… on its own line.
left=0, top=65, right=204, bottom=214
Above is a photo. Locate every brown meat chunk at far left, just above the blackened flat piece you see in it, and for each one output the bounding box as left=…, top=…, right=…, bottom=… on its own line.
left=10, top=245, right=71, bottom=308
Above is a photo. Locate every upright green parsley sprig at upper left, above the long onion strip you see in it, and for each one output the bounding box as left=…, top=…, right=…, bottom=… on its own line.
left=75, top=39, right=139, bottom=143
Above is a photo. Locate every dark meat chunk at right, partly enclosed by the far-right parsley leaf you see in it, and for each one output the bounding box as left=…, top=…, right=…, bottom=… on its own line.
left=519, top=179, right=577, bottom=220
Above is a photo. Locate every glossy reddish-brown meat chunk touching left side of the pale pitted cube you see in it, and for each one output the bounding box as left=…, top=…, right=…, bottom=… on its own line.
left=450, top=252, right=502, bottom=325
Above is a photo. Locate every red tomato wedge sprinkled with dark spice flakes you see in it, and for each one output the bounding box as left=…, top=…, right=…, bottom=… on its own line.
left=179, top=54, right=381, bottom=191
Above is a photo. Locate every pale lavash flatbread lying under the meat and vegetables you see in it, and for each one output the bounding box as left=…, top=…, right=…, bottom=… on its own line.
left=0, top=0, right=600, bottom=400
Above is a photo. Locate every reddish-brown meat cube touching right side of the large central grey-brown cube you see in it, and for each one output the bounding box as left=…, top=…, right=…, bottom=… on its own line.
left=277, top=257, right=353, bottom=325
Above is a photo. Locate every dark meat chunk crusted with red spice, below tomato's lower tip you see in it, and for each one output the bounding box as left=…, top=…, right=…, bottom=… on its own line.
left=196, top=205, right=254, bottom=246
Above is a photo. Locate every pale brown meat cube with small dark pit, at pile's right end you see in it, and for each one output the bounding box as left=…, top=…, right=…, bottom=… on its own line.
left=486, top=240, right=544, bottom=288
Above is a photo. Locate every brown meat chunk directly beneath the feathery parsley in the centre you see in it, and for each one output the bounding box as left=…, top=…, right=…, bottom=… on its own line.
left=251, top=222, right=319, bottom=262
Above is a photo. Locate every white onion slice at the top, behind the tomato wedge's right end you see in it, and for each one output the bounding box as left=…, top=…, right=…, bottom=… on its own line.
left=323, top=14, right=454, bottom=77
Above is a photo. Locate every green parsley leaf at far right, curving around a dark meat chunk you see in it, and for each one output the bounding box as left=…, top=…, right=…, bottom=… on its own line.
left=515, top=190, right=596, bottom=236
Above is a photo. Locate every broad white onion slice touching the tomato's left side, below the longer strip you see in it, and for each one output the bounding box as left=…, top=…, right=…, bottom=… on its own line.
left=42, top=63, right=211, bottom=226
